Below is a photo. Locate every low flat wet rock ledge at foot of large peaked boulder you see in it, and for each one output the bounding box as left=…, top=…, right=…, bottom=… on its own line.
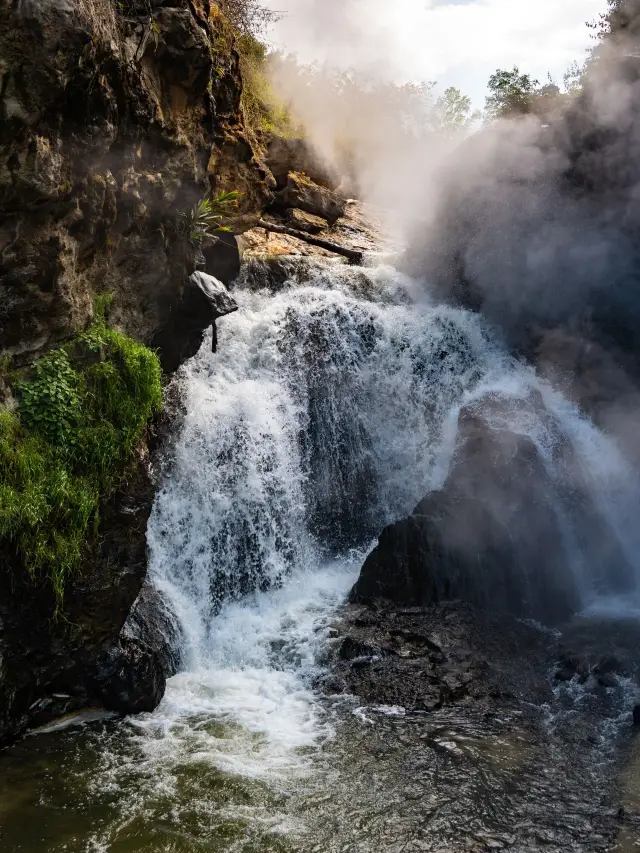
left=328, top=602, right=553, bottom=711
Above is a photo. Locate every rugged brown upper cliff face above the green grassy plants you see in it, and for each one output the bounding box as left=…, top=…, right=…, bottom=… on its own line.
left=0, top=0, right=273, bottom=364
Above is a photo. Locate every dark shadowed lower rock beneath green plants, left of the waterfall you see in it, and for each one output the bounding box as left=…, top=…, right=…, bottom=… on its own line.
left=0, top=456, right=164, bottom=743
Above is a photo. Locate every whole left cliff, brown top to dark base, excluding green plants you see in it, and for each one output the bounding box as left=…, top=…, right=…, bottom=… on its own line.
left=0, top=0, right=275, bottom=742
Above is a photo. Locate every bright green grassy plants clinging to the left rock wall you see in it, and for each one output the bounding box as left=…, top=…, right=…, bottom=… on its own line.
left=0, top=321, right=162, bottom=614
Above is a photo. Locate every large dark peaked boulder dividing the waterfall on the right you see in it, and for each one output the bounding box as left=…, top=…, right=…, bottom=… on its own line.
left=351, top=397, right=632, bottom=623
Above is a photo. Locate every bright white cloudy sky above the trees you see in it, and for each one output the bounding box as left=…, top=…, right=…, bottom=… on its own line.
left=267, top=0, right=607, bottom=106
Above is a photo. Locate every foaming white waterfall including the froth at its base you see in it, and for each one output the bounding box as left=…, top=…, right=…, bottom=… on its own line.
left=142, top=260, right=638, bottom=780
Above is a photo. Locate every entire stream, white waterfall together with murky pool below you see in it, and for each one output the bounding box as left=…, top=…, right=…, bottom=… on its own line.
left=0, top=256, right=640, bottom=853
